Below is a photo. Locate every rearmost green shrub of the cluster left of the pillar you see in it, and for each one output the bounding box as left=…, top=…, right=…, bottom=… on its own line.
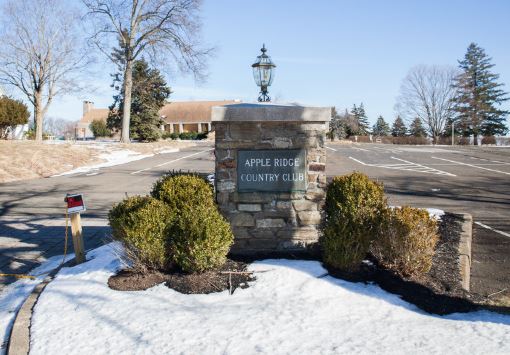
left=151, top=171, right=216, bottom=211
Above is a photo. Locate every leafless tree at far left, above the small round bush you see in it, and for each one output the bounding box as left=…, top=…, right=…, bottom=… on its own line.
left=0, top=0, right=87, bottom=140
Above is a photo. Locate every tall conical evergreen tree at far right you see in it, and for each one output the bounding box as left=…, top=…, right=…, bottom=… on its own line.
left=453, top=43, right=509, bottom=145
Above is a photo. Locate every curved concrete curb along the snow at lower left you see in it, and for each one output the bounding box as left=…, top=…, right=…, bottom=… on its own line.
left=6, top=258, right=74, bottom=355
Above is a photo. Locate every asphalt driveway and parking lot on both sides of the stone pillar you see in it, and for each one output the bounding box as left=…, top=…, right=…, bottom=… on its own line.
left=0, top=143, right=510, bottom=296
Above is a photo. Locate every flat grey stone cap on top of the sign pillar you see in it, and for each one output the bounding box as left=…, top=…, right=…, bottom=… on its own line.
left=211, top=103, right=331, bottom=122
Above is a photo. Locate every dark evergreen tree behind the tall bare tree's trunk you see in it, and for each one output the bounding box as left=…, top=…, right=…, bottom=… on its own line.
left=107, top=58, right=171, bottom=141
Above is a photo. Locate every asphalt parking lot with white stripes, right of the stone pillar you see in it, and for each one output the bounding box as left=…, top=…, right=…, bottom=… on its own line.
left=326, top=143, right=510, bottom=296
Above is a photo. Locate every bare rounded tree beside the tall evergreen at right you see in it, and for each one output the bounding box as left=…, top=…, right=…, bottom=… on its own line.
left=396, top=65, right=457, bottom=143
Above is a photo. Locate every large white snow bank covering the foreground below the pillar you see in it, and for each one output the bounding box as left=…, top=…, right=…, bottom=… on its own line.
left=31, top=245, right=510, bottom=354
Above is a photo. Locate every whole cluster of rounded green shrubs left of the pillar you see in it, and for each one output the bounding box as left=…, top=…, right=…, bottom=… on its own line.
left=108, top=172, right=234, bottom=272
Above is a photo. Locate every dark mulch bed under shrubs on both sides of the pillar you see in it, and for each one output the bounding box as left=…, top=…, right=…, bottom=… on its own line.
left=108, top=213, right=510, bottom=315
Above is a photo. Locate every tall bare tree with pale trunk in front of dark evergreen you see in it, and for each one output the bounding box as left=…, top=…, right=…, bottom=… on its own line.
left=82, top=0, right=211, bottom=143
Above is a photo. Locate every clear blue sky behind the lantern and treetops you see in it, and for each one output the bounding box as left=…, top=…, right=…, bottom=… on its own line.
left=43, top=0, right=510, bottom=128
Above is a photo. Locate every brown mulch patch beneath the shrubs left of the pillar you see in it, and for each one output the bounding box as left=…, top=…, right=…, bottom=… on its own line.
left=108, top=260, right=254, bottom=294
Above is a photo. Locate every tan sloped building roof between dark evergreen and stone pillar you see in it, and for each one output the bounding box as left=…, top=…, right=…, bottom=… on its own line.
left=159, top=100, right=238, bottom=123
